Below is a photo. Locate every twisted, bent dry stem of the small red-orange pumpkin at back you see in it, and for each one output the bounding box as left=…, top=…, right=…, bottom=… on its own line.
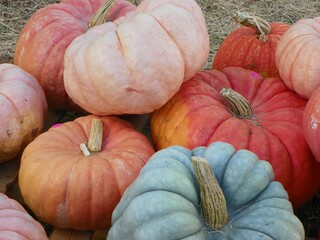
left=235, top=12, right=271, bottom=42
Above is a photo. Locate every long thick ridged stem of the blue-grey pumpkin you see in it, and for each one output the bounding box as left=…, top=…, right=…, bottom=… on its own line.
left=191, top=157, right=228, bottom=230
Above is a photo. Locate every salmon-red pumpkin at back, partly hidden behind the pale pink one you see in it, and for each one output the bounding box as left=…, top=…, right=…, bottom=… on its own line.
left=14, top=0, right=134, bottom=110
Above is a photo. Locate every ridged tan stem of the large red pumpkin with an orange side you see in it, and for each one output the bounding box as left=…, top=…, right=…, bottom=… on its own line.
left=220, top=88, right=262, bottom=127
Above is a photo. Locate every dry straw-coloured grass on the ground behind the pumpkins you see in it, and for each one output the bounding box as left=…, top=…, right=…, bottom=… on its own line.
left=0, top=0, right=320, bottom=237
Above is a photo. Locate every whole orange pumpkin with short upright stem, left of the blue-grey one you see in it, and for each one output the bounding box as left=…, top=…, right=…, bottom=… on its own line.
left=19, top=115, right=154, bottom=230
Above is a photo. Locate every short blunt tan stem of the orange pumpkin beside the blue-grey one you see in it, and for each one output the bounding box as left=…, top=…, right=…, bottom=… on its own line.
left=80, top=118, right=103, bottom=157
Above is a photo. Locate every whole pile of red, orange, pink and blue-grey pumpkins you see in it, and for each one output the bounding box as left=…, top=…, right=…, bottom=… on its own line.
left=0, top=0, right=320, bottom=240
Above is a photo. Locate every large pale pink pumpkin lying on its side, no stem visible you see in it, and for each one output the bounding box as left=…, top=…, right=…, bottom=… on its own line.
left=64, top=0, right=209, bottom=115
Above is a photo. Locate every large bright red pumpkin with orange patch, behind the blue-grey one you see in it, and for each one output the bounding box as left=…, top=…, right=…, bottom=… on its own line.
left=150, top=67, right=320, bottom=208
